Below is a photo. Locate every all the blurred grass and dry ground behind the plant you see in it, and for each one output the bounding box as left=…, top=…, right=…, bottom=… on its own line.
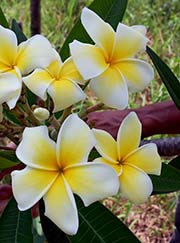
left=0, top=0, right=180, bottom=243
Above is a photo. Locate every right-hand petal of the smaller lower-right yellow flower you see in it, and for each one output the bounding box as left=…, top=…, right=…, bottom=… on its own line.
left=124, top=143, right=162, bottom=175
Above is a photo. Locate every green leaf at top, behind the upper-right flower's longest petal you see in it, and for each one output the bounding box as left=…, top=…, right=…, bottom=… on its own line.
left=60, top=0, right=128, bottom=61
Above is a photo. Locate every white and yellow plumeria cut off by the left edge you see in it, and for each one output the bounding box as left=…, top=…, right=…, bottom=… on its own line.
left=0, top=26, right=55, bottom=109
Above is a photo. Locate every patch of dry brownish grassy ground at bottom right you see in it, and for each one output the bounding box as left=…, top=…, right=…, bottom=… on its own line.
left=104, top=193, right=177, bottom=243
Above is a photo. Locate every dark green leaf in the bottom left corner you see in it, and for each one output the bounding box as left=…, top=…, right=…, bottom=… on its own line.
left=0, top=198, right=33, bottom=243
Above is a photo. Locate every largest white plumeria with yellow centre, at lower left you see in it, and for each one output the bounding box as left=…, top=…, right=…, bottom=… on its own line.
left=12, top=114, right=119, bottom=235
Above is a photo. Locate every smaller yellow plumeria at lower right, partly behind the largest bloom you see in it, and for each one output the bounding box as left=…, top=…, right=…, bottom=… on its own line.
left=93, top=112, right=161, bottom=203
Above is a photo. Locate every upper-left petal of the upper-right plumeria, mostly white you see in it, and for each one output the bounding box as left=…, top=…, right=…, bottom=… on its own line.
left=81, top=8, right=115, bottom=58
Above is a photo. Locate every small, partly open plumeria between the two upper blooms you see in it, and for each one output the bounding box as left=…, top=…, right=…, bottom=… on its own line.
left=23, top=53, right=86, bottom=112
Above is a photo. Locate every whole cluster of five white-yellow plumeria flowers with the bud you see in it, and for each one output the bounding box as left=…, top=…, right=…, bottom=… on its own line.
left=0, top=8, right=161, bottom=235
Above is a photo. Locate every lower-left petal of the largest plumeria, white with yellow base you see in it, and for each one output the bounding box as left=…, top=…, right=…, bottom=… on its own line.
left=11, top=167, right=58, bottom=211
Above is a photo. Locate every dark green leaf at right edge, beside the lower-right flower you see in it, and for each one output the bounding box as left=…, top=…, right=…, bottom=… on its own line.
left=150, top=162, right=180, bottom=194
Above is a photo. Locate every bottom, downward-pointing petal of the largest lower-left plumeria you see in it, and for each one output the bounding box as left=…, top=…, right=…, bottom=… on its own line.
left=44, top=175, right=79, bottom=235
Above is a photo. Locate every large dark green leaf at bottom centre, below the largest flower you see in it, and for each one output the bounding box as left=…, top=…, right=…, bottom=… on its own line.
left=69, top=199, right=140, bottom=243
